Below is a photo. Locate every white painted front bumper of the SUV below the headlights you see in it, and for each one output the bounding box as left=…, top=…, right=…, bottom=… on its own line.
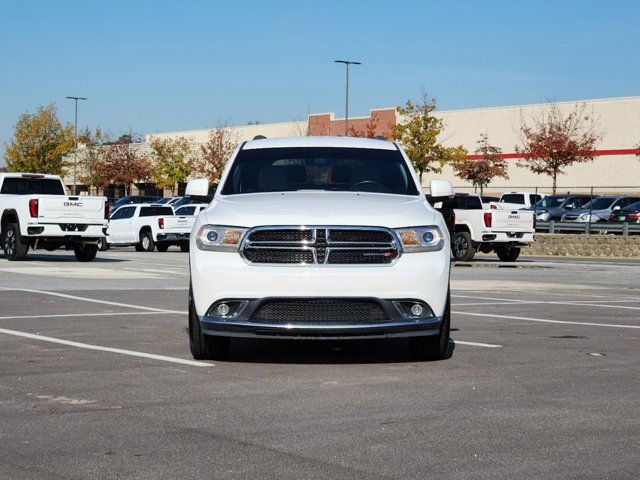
left=190, top=248, right=451, bottom=322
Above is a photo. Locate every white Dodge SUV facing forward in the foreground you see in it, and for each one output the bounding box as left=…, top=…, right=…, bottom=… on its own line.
left=187, top=137, right=453, bottom=359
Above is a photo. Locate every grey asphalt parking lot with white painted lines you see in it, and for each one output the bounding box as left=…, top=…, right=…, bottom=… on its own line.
left=0, top=249, right=640, bottom=479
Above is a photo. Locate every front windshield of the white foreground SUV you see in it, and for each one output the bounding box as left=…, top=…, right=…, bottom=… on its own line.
left=222, top=147, right=418, bottom=195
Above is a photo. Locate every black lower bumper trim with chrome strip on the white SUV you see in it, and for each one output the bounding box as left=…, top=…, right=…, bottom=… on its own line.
left=199, top=298, right=442, bottom=340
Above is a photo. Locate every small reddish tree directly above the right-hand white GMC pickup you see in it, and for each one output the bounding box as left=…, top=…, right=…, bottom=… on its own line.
left=452, top=133, right=509, bottom=195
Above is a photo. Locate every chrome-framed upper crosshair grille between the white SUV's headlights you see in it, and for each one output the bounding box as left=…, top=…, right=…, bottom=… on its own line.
left=240, top=226, right=400, bottom=265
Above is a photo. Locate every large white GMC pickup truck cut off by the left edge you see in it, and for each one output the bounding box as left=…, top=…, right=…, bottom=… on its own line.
left=0, top=173, right=109, bottom=262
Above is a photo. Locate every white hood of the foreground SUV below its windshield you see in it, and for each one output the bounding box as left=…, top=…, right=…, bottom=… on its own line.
left=206, top=191, right=436, bottom=228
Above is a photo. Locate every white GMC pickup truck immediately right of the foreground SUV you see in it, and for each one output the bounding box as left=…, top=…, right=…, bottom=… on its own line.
left=435, top=194, right=535, bottom=262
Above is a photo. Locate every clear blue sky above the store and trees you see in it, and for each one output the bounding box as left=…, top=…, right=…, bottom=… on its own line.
left=0, top=0, right=640, bottom=152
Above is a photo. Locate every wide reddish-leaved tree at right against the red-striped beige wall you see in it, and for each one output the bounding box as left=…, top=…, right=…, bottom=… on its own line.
left=515, top=104, right=602, bottom=194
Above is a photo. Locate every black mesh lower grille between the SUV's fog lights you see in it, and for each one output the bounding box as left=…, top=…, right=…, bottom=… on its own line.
left=249, top=298, right=389, bottom=325
